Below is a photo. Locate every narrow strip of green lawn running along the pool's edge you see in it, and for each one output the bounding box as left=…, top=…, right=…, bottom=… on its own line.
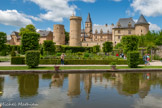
left=0, top=66, right=162, bottom=70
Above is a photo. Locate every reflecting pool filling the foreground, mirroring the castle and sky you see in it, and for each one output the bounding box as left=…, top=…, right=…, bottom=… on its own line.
left=0, top=72, right=162, bottom=108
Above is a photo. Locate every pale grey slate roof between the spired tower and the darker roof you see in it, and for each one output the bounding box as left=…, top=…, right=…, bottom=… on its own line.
left=93, top=25, right=113, bottom=34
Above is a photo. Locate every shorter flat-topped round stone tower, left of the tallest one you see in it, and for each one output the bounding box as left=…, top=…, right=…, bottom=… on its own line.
left=53, top=24, right=65, bottom=45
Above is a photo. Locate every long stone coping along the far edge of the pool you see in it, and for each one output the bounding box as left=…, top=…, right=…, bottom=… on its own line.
left=0, top=69, right=162, bottom=74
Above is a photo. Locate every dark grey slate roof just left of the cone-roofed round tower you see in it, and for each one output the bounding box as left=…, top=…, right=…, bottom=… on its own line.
left=115, top=18, right=135, bottom=28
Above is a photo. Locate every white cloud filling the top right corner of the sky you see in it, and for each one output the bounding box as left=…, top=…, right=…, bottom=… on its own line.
left=131, top=0, right=162, bottom=16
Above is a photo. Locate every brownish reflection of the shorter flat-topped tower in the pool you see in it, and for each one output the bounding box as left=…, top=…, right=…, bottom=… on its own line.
left=50, top=73, right=64, bottom=88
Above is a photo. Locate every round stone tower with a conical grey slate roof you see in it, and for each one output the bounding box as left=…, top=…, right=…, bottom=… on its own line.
left=135, top=15, right=150, bottom=35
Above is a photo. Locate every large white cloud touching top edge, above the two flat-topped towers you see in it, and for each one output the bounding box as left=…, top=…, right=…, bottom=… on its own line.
left=28, top=0, right=77, bottom=22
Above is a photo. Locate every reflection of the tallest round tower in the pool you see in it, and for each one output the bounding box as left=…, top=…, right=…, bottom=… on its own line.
left=68, top=74, right=80, bottom=97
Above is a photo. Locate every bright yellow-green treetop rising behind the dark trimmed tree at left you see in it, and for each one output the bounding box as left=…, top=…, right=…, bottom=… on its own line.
left=19, top=24, right=36, bottom=36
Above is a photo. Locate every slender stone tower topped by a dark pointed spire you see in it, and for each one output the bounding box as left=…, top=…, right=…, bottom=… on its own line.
left=85, top=13, right=92, bottom=38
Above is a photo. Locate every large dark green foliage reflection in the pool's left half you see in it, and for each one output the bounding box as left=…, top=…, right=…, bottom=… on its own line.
left=18, top=74, right=39, bottom=97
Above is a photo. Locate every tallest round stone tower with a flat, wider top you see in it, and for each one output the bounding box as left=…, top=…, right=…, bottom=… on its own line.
left=69, top=15, right=82, bottom=46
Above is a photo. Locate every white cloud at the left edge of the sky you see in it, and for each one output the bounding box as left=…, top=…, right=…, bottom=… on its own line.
left=0, top=10, right=32, bottom=27
